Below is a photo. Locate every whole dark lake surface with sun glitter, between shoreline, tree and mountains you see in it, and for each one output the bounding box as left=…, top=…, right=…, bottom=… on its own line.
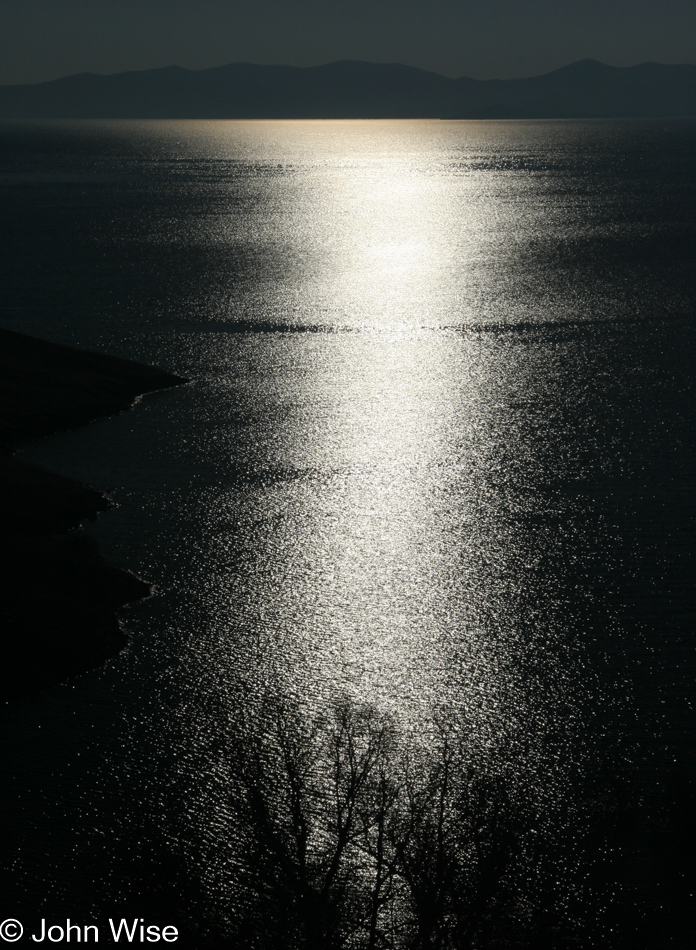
left=0, top=122, right=696, bottom=946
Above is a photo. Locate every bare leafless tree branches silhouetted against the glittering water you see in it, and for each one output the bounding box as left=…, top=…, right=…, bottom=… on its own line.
left=231, top=702, right=519, bottom=950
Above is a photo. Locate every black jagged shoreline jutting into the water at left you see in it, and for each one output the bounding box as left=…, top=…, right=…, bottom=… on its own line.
left=0, top=329, right=187, bottom=701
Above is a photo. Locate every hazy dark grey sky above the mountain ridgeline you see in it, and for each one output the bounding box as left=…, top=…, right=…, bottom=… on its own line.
left=0, top=0, right=696, bottom=83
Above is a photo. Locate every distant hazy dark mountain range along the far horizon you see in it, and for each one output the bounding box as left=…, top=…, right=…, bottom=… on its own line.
left=0, top=59, right=696, bottom=119
